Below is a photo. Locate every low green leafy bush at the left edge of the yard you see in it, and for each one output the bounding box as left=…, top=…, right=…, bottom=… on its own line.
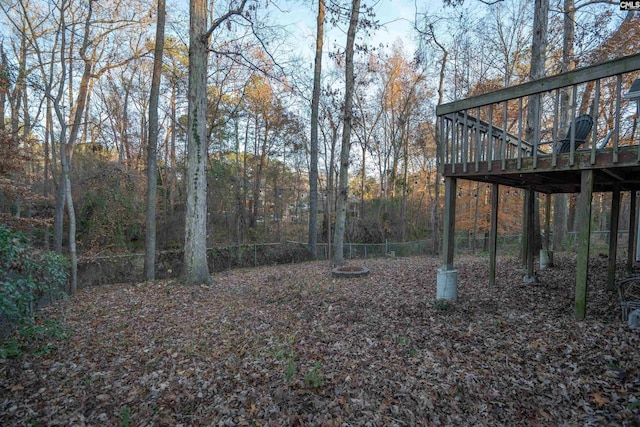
left=0, top=225, right=69, bottom=330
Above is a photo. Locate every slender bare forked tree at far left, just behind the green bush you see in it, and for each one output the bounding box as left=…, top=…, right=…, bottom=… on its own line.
left=9, top=0, right=152, bottom=294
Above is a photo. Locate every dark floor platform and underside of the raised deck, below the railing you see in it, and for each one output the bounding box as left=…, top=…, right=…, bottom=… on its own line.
left=444, top=145, right=640, bottom=194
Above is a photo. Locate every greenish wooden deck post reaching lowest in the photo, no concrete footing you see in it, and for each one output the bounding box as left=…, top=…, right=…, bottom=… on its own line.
left=575, top=169, right=593, bottom=320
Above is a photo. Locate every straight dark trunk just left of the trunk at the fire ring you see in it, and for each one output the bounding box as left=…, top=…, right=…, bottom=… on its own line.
left=309, top=0, right=325, bottom=259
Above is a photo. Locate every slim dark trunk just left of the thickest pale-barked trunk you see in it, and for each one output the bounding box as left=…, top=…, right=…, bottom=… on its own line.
left=144, top=0, right=165, bottom=280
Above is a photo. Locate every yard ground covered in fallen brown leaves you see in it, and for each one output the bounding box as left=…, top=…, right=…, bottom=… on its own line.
left=0, top=252, right=640, bottom=426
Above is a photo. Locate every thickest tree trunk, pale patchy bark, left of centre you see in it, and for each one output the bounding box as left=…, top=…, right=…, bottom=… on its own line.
left=184, top=0, right=211, bottom=285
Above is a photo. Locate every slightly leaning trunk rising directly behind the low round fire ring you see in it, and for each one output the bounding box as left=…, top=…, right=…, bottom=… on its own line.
left=333, top=0, right=360, bottom=265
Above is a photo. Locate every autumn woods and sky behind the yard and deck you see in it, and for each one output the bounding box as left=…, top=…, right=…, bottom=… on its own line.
left=0, top=0, right=640, bottom=286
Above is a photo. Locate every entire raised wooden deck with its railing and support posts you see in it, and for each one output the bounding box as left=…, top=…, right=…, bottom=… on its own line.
left=436, top=54, right=640, bottom=319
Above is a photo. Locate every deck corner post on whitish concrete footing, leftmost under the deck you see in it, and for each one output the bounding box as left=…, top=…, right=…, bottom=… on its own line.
left=436, top=176, right=458, bottom=301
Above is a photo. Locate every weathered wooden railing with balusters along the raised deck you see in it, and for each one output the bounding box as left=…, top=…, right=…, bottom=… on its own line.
left=436, top=54, right=640, bottom=174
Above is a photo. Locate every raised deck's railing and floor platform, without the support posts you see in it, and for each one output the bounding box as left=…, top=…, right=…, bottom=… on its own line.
left=436, top=54, right=640, bottom=193
